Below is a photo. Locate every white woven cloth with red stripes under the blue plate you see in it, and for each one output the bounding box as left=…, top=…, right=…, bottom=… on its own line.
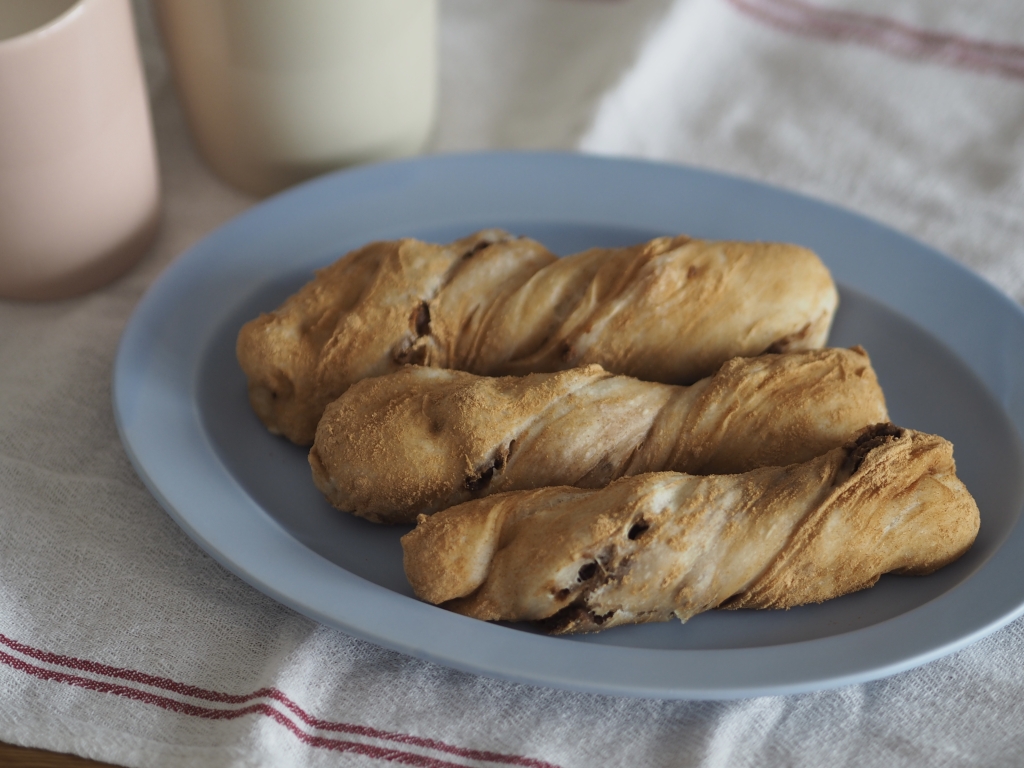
left=0, top=0, right=1024, bottom=768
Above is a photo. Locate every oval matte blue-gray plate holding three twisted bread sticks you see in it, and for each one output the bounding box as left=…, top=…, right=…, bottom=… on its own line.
left=114, top=154, right=1024, bottom=698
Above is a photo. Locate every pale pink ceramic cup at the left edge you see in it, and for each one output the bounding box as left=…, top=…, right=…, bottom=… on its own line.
left=0, top=0, right=160, bottom=299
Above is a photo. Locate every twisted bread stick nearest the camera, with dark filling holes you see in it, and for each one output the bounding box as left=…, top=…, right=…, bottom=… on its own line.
left=401, top=425, right=979, bottom=634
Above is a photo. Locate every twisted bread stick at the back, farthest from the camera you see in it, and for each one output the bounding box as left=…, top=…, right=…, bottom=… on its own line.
left=237, top=230, right=838, bottom=444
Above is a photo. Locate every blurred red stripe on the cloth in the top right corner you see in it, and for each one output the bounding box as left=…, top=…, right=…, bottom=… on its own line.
left=727, top=0, right=1024, bottom=79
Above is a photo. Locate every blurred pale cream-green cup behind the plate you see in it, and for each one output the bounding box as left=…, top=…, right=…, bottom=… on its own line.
left=156, top=0, right=437, bottom=195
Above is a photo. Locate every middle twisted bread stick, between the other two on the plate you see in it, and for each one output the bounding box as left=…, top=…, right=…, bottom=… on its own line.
left=309, top=347, right=888, bottom=522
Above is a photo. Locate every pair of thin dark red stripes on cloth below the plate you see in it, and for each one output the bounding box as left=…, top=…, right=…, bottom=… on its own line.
left=0, top=634, right=558, bottom=768
